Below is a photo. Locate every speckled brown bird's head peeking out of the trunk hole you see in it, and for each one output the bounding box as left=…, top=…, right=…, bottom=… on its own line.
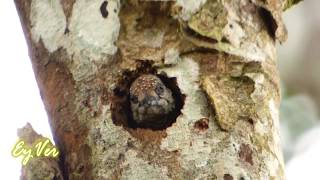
left=130, top=74, right=175, bottom=126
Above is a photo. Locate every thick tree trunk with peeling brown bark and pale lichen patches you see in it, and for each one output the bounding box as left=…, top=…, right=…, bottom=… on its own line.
left=15, top=0, right=297, bottom=180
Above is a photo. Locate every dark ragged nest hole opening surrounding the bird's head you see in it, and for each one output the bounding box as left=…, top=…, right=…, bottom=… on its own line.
left=111, top=61, right=185, bottom=130
